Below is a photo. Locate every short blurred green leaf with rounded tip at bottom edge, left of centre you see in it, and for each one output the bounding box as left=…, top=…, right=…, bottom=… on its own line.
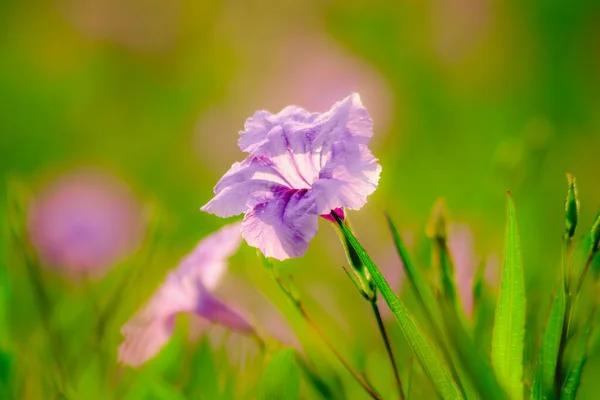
left=258, top=349, right=300, bottom=400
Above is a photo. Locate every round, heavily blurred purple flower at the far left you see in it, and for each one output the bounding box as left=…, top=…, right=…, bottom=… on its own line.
left=28, top=171, right=144, bottom=273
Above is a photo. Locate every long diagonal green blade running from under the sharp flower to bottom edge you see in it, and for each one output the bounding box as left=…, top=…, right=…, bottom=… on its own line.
left=332, top=212, right=463, bottom=399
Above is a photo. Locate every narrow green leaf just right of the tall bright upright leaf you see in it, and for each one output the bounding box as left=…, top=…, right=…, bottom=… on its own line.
left=531, top=279, right=566, bottom=399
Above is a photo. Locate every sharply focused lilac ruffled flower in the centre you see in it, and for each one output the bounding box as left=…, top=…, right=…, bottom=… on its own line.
left=202, top=94, right=381, bottom=260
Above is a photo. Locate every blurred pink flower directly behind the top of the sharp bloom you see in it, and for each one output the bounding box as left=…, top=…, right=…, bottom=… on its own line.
left=258, top=33, right=394, bottom=139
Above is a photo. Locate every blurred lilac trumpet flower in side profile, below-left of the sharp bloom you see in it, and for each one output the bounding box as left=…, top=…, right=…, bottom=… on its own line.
left=119, top=223, right=254, bottom=367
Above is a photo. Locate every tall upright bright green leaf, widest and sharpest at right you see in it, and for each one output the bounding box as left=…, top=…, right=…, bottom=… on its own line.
left=492, top=193, right=525, bottom=400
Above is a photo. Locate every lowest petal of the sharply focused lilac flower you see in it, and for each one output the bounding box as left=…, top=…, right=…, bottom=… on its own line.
left=242, top=189, right=318, bottom=260
